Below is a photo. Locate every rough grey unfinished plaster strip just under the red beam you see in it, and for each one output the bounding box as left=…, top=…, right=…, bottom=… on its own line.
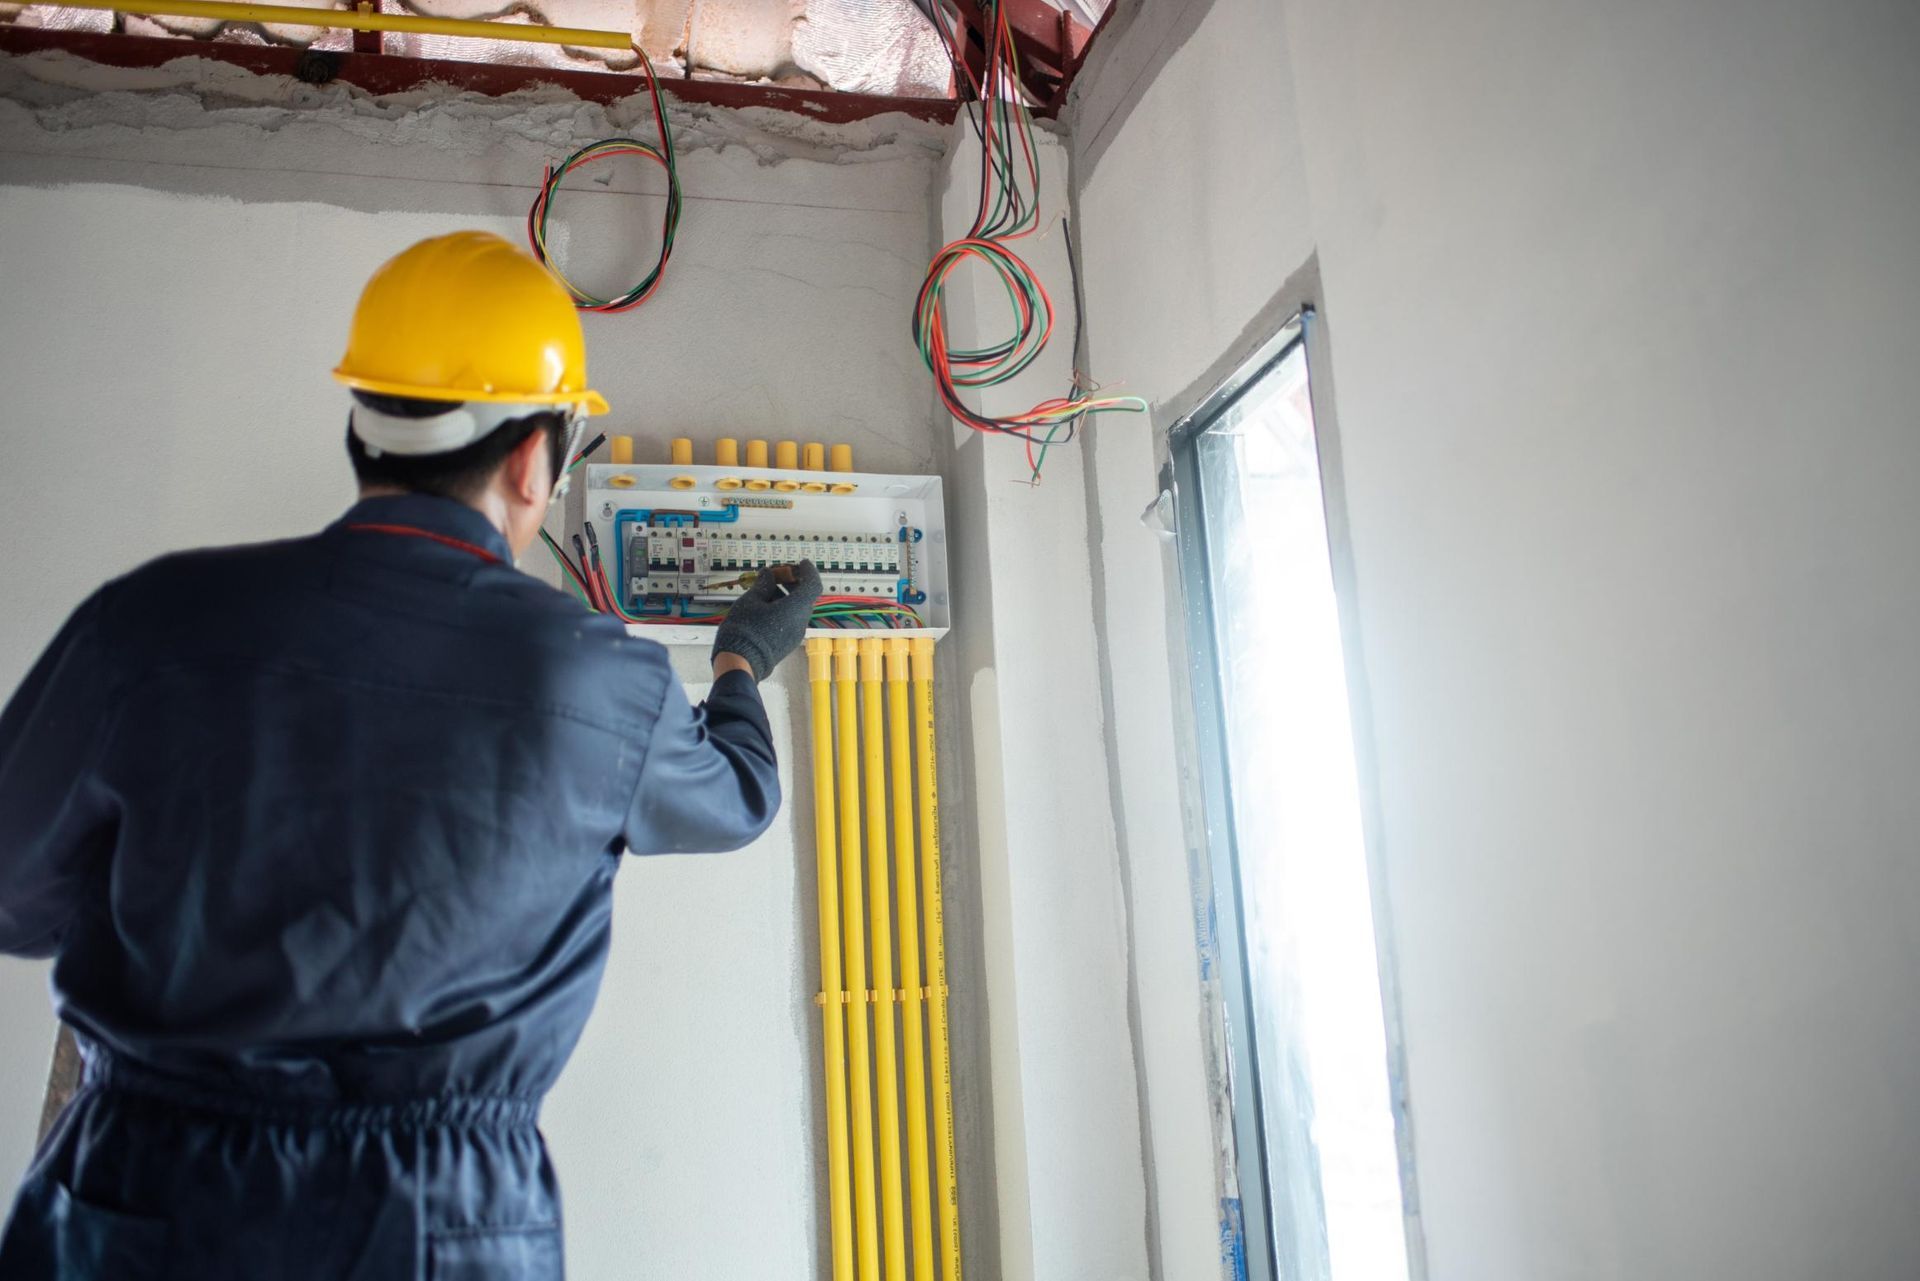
left=0, top=41, right=948, bottom=219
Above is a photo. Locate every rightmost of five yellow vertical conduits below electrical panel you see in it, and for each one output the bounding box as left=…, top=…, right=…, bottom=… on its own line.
left=912, top=636, right=960, bottom=1281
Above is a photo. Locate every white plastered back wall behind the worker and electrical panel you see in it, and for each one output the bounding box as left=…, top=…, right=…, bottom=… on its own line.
left=0, top=52, right=948, bottom=1281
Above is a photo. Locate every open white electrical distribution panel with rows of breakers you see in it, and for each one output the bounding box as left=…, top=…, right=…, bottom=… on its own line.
left=584, top=463, right=950, bottom=645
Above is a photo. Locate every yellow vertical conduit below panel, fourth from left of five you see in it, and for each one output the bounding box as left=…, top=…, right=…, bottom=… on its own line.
left=887, top=641, right=933, bottom=1281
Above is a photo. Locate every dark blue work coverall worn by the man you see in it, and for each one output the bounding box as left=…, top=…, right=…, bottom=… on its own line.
left=0, top=495, right=780, bottom=1281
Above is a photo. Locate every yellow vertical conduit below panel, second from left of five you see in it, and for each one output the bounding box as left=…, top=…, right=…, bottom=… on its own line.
left=829, top=645, right=879, bottom=1281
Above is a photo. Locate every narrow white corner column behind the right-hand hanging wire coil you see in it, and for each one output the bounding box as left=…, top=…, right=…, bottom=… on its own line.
left=939, top=125, right=1148, bottom=1281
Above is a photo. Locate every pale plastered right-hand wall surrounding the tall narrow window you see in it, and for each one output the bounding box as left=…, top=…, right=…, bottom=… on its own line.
left=1077, top=0, right=1920, bottom=1281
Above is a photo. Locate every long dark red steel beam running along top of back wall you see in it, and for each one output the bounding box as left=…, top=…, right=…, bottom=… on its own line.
left=0, top=25, right=958, bottom=125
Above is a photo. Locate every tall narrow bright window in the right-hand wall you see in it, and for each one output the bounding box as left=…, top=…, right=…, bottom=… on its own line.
left=1173, top=313, right=1409, bottom=1281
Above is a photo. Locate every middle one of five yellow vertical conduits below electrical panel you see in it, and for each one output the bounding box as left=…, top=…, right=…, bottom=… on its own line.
left=864, top=641, right=906, bottom=1281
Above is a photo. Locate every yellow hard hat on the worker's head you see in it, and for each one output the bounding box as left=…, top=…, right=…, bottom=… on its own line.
left=334, top=230, right=607, bottom=413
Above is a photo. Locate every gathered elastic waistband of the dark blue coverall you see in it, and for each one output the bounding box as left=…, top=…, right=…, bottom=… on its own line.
left=81, top=1047, right=540, bottom=1129
